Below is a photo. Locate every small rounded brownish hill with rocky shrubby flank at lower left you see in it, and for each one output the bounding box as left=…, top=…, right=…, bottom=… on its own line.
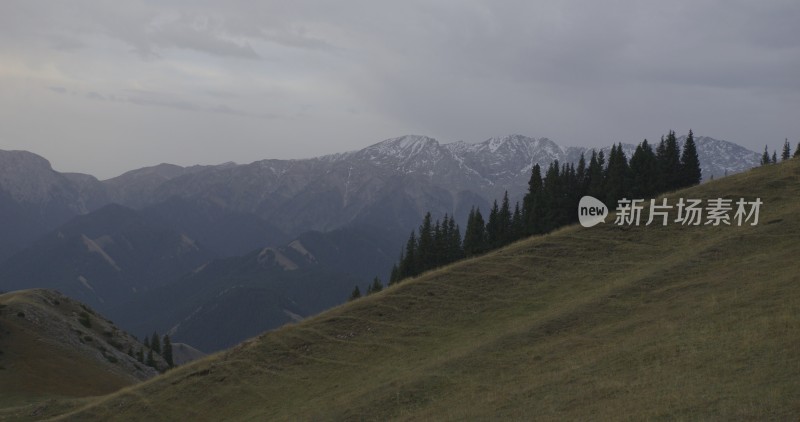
left=0, top=289, right=162, bottom=407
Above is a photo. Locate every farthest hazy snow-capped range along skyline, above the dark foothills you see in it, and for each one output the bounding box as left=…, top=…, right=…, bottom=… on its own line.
left=0, top=135, right=759, bottom=255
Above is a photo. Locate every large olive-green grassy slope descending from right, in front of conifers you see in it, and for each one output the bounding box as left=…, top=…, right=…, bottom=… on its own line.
left=6, top=160, right=800, bottom=421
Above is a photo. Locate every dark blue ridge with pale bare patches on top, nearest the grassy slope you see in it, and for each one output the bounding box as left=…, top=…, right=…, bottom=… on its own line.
left=114, top=237, right=360, bottom=352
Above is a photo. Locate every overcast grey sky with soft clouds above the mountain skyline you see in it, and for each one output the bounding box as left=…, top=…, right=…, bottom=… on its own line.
left=0, top=0, right=800, bottom=178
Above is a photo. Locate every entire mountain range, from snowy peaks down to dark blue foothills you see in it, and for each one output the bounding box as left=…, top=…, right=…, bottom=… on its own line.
left=0, top=135, right=760, bottom=351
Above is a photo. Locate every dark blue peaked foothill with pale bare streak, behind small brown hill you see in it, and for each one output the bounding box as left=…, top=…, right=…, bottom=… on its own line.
left=0, top=204, right=212, bottom=317
